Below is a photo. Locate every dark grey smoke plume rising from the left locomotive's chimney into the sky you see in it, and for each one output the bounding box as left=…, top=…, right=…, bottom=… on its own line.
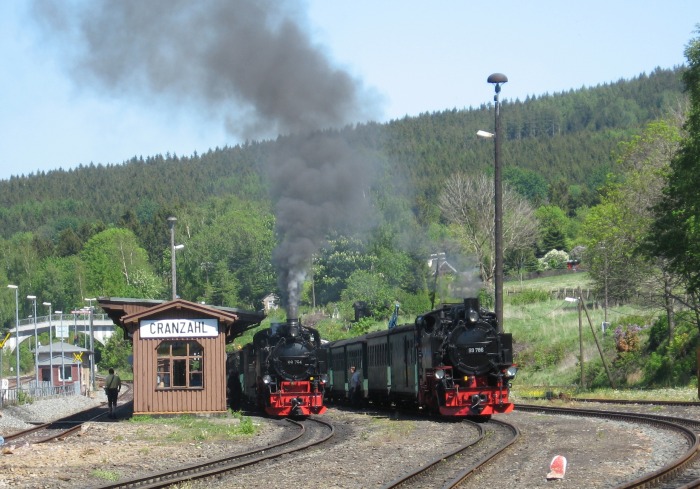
left=33, top=0, right=376, bottom=317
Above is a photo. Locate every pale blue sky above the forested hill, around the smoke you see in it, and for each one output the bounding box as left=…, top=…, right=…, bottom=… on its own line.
left=0, top=0, right=700, bottom=179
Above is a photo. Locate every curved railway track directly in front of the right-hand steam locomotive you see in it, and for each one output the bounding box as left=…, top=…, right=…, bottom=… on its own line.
left=383, top=419, right=520, bottom=489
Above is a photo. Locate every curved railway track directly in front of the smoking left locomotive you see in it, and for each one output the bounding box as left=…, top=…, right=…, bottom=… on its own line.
left=90, top=417, right=335, bottom=489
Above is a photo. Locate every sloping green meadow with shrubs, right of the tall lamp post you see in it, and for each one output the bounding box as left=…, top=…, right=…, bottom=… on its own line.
left=503, top=272, right=698, bottom=401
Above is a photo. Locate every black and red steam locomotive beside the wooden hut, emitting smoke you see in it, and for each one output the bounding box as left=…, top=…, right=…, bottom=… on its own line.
left=227, top=319, right=328, bottom=417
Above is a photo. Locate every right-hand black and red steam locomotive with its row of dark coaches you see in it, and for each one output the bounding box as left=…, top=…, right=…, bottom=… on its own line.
left=325, top=298, right=517, bottom=420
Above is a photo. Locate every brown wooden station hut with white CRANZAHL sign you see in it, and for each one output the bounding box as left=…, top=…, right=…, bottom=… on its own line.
left=98, top=298, right=265, bottom=414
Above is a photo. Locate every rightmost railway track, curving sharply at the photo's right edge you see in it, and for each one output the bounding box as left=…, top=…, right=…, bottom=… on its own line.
left=516, top=404, right=700, bottom=489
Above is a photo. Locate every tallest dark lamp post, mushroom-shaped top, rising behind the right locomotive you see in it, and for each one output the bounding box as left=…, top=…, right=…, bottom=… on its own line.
left=487, top=73, right=508, bottom=333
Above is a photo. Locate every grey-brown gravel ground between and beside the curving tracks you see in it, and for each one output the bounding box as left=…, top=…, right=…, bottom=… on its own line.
left=0, top=397, right=699, bottom=489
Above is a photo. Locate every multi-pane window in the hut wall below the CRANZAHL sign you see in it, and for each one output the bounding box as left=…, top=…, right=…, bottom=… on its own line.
left=156, top=341, right=204, bottom=389
